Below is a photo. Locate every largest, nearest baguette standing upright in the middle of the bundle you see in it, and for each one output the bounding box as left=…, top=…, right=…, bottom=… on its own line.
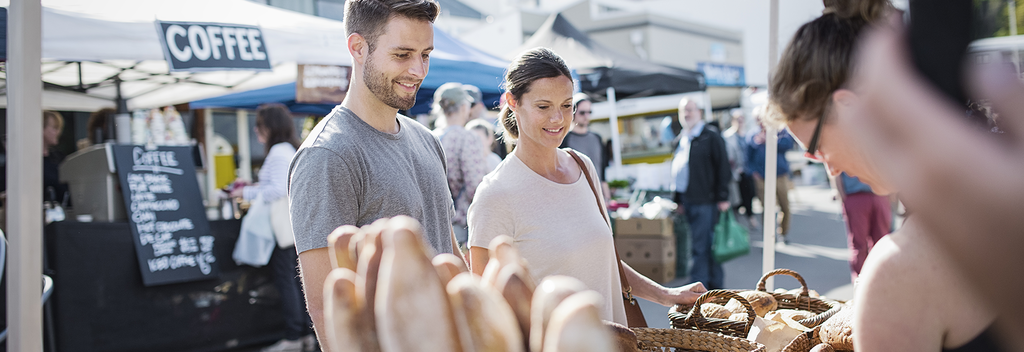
left=374, top=216, right=462, bottom=352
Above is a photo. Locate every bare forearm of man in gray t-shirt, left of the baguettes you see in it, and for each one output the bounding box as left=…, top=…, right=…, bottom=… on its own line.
left=299, top=248, right=331, bottom=346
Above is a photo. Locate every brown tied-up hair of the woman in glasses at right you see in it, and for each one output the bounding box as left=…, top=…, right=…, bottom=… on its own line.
left=765, top=0, right=893, bottom=124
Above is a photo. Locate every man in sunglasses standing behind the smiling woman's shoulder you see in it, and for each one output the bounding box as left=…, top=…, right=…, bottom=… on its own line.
left=558, top=92, right=611, bottom=202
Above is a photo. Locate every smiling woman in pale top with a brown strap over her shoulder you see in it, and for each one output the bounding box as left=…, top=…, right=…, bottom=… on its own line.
left=469, top=48, right=706, bottom=324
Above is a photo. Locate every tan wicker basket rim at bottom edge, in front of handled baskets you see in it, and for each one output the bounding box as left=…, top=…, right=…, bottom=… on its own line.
left=633, top=327, right=765, bottom=352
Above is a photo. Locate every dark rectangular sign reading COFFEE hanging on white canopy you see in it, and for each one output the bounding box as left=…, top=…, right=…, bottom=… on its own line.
left=157, top=20, right=271, bottom=72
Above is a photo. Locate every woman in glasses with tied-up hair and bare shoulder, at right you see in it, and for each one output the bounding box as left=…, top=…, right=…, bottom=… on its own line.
left=766, top=0, right=998, bottom=352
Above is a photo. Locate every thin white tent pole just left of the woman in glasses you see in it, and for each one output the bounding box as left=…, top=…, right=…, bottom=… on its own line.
left=761, top=0, right=778, bottom=292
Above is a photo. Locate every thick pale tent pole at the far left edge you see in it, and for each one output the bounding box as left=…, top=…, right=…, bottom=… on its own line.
left=6, top=0, right=43, bottom=351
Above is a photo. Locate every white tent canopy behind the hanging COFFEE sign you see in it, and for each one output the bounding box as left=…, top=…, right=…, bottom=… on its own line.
left=0, top=0, right=351, bottom=109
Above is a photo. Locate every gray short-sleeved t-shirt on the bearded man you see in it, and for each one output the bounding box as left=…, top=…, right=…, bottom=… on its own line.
left=288, top=105, right=455, bottom=254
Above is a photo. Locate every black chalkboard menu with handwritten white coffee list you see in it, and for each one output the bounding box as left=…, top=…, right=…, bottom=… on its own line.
left=114, top=145, right=218, bottom=287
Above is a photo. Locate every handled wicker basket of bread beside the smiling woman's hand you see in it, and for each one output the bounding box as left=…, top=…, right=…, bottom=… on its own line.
left=669, top=290, right=756, bottom=338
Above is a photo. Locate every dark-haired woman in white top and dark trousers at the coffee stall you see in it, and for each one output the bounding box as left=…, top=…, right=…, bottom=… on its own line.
left=231, top=103, right=315, bottom=351
